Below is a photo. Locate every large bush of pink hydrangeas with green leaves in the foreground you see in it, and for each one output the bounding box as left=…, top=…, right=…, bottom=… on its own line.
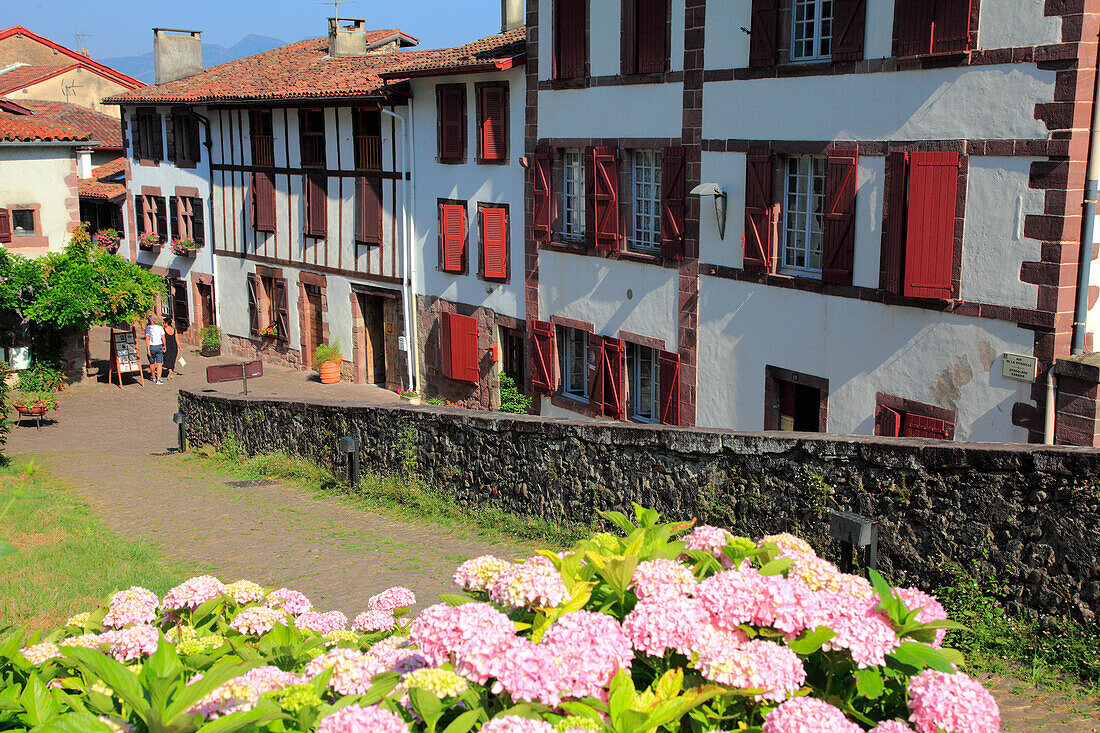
left=0, top=507, right=1000, bottom=733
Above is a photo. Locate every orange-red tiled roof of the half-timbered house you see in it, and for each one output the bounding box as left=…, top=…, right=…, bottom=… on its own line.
left=103, top=30, right=417, bottom=105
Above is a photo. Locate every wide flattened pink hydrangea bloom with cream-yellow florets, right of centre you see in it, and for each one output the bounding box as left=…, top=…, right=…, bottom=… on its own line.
left=694, top=639, right=806, bottom=701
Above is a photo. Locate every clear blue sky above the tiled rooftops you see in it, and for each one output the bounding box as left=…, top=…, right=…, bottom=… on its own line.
left=11, top=0, right=501, bottom=58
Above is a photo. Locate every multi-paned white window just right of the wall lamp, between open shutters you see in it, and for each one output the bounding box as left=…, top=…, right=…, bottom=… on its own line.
left=780, top=155, right=828, bottom=277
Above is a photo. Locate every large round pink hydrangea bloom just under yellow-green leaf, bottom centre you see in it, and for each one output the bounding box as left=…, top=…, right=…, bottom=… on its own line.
left=539, top=611, right=634, bottom=698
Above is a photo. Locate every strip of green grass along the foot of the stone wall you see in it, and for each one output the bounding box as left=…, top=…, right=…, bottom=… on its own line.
left=191, top=441, right=593, bottom=548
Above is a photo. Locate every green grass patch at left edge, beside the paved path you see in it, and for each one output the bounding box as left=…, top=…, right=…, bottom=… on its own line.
left=0, top=460, right=186, bottom=631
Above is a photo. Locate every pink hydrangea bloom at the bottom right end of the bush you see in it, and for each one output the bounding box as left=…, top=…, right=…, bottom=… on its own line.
left=909, top=669, right=1001, bottom=733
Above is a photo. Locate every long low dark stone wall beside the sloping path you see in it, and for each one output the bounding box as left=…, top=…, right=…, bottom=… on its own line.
left=179, top=392, right=1100, bottom=622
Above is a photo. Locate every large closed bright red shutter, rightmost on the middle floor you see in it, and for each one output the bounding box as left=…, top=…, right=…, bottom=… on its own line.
left=904, top=153, right=959, bottom=298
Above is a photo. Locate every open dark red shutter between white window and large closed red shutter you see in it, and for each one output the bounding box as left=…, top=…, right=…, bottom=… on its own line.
left=822, top=150, right=859, bottom=285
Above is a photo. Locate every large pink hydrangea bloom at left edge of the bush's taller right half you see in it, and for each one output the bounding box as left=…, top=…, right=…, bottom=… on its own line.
left=409, top=603, right=516, bottom=685
